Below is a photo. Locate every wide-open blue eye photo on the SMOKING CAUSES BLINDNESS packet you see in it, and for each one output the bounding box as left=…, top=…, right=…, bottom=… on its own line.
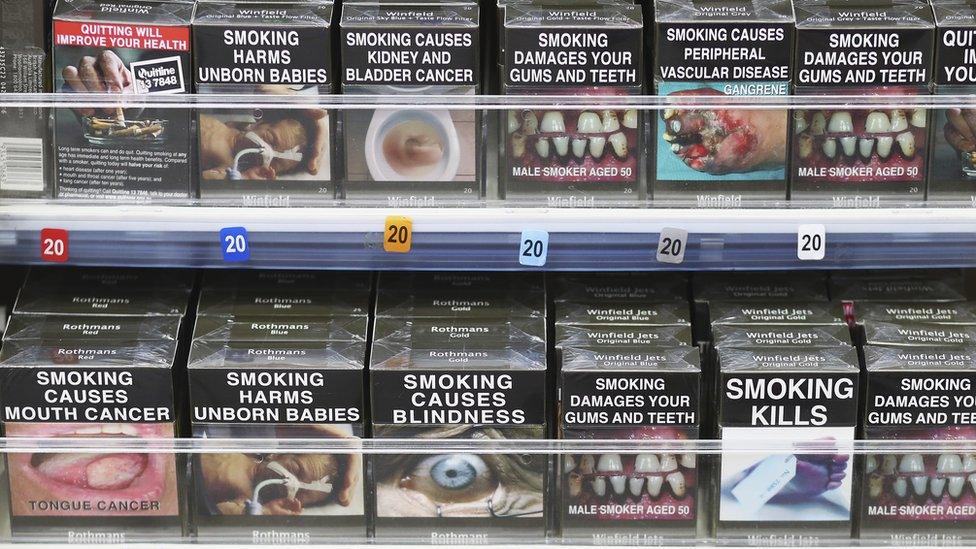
left=373, top=426, right=546, bottom=518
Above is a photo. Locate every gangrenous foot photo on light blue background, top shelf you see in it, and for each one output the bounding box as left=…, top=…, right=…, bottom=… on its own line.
left=658, top=86, right=787, bottom=180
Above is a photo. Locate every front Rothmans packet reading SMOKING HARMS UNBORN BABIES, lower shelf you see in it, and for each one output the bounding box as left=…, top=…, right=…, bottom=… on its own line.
left=188, top=340, right=366, bottom=544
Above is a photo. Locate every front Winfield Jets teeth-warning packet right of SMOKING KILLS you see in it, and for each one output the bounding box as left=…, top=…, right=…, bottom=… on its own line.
left=860, top=346, right=976, bottom=545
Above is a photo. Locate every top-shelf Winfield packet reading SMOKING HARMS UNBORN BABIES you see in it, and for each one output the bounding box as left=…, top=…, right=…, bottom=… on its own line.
left=193, top=0, right=336, bottom=207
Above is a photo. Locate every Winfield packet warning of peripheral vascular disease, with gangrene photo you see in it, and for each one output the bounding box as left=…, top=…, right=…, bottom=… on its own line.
left=652, top=0, right=794, bottom=208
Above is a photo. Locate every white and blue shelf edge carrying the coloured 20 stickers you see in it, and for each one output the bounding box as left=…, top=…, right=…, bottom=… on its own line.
left=0, top=201, right=976, bottom=270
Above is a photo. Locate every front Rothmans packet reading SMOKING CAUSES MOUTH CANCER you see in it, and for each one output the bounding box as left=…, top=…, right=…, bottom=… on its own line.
left=0, top=338, right=185, bottom=543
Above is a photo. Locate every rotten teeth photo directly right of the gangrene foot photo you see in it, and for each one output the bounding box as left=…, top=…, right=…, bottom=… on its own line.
left=793, top=109, right=928, bottom=182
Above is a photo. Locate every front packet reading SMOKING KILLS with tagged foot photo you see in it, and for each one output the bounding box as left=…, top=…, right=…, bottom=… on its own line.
left=715, top=347, right=859, bottom=544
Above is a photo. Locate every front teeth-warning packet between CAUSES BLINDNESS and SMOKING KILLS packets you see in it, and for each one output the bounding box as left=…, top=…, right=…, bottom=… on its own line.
left=559, top=344, right=704, bottom=545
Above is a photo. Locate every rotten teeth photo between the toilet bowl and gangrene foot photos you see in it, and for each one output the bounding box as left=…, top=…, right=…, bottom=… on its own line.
left=506, top=109, right=640, bottom=182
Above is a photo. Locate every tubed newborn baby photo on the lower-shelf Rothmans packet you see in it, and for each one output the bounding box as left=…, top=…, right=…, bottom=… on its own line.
left=195, top=425, right=363, bottom=516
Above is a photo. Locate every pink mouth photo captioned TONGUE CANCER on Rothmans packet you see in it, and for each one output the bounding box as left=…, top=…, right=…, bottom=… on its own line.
left=6, top=423, right=179, bottom=517
